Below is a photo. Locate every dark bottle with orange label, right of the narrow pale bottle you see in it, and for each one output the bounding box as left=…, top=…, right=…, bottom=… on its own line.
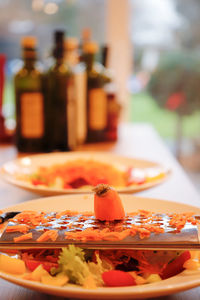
left=82, top=41, right=110, bottom=142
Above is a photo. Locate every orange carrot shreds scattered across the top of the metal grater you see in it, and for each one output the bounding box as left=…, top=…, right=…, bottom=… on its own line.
left=3, top=210, right=200, bottom=242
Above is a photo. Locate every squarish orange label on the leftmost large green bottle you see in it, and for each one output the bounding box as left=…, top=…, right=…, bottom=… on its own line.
left=20, top=93, right=44, bottom=138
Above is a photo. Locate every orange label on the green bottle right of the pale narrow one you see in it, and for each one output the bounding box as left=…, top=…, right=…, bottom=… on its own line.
left=89, top=88, right=107, bottom=130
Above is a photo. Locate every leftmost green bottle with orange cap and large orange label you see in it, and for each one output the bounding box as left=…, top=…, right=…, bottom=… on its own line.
left=14, top=36, right=45, bottom=152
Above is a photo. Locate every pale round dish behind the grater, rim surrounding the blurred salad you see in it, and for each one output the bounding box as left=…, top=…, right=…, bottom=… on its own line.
left=0, top=152, right=171, bottom=196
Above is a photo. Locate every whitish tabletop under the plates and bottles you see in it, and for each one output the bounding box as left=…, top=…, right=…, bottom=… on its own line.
left=0, top=123, right=200, bottom=300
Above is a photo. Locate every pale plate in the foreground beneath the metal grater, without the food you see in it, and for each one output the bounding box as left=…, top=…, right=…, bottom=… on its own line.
left=0, top=194, right=200, bottom=299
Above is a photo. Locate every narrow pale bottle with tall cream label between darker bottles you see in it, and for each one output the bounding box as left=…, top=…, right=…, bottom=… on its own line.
left=65, top=38, right=87, bottom=145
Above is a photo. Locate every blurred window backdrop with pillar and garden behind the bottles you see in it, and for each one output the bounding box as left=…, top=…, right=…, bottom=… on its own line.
left=0, top=0, right=200, bottom=190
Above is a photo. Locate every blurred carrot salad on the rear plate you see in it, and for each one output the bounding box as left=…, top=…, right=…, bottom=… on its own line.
left=26, top=159, right=166, bottom=189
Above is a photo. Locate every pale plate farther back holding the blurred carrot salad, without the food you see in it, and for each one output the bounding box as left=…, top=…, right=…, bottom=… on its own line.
left=0, top=152, right=170, bottom=196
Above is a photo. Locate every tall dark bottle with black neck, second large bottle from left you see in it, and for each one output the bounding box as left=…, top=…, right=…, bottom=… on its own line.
left=44, top=30, right=76, bottom=151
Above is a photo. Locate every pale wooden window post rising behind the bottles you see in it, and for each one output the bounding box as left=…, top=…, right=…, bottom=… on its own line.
left=106, top=0, right=133, bottom=120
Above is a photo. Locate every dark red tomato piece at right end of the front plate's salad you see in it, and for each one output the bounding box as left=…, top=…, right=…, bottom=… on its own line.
left=160, top=251, right=191, bottom=279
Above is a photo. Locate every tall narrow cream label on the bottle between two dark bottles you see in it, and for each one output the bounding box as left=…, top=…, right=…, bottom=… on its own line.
left=74, top=72, right=87, bottom=144
